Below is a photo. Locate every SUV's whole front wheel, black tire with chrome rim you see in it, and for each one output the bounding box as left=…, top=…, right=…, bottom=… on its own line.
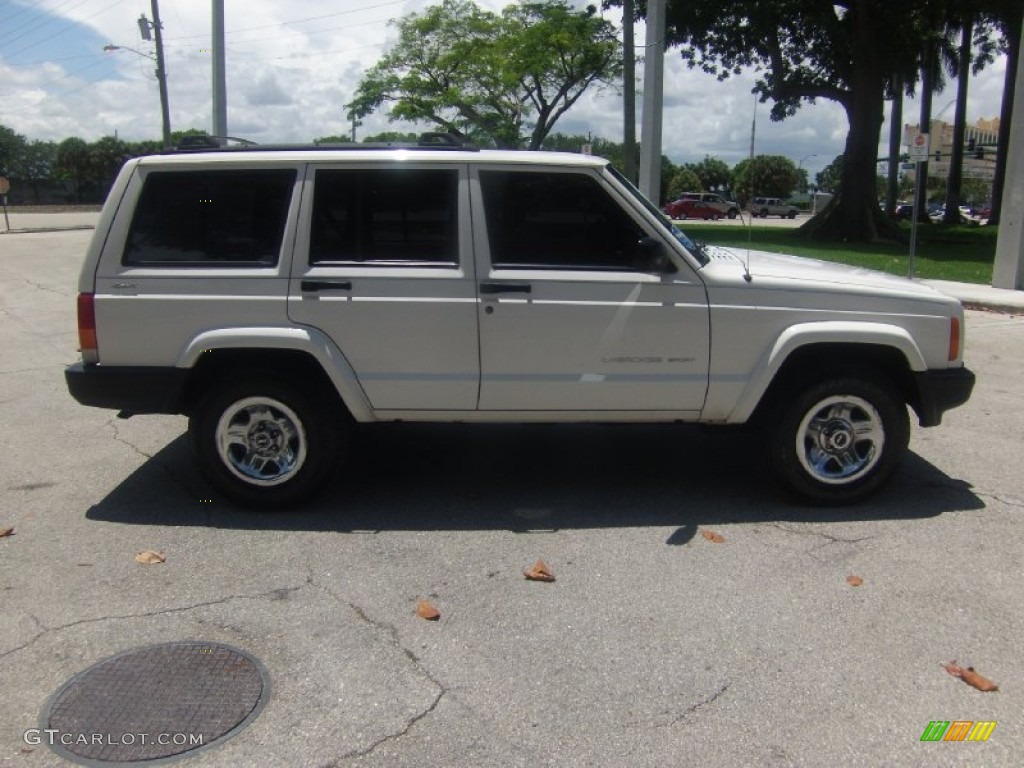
left=767, top=376, right=910, bottom=505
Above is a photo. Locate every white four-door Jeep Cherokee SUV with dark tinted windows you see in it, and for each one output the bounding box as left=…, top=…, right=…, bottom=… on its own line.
left=67, top=138, right=974, bottom=508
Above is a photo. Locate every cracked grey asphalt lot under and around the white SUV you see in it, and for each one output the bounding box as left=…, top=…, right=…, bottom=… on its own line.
left=0, top=231, right=1024, bottom=768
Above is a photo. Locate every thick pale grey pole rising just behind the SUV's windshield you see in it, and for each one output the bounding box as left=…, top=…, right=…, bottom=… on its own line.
left=640, top=0, right=665, bottom=205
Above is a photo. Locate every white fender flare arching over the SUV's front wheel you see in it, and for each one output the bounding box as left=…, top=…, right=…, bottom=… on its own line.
left=727, top=321, right=928, bottom=423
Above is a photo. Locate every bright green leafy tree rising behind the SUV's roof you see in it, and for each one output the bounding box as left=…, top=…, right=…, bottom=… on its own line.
left=346, top=0, right=622, bottom=150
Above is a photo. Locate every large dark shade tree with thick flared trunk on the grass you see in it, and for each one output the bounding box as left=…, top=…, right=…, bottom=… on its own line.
left=647, top=0, right=934, bottom=241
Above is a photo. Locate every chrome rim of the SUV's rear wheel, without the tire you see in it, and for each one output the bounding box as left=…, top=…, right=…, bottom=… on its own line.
left=215, top=396, right=307, bottom=486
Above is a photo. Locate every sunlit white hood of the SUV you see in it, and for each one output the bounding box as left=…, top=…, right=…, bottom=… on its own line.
left=707, top=246, right=949, bottom=300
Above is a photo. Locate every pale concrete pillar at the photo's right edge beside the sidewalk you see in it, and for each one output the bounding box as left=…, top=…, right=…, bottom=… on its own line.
left=992, top=13, right=1024, bottom=291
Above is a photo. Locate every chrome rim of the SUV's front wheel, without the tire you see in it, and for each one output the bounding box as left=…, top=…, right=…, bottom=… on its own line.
left=797, top=394, right=886, bottom=485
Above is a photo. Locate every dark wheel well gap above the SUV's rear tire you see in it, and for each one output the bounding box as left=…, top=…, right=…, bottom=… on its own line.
left=181, top=349, right=344, bottom=415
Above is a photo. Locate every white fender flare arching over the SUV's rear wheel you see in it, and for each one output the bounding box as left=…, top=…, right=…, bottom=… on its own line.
left=174, top=327, right=375, bottom=422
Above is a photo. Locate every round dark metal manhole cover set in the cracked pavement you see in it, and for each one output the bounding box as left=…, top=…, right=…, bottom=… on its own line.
left=42, top=642, right=270, bottom=765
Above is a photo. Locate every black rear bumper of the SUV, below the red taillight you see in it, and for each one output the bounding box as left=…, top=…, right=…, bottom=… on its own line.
left=65, top=362, right=188, bottom=414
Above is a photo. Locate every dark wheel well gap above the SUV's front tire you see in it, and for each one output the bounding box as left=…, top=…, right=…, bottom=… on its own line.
left=752, top=344, right=920, bottom=419
